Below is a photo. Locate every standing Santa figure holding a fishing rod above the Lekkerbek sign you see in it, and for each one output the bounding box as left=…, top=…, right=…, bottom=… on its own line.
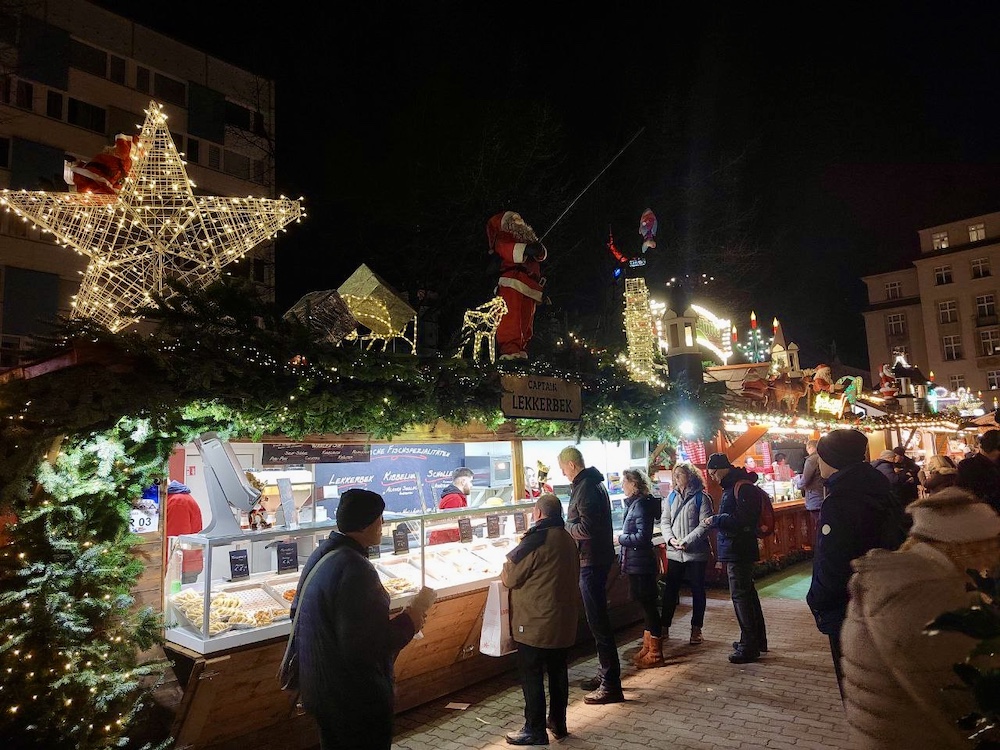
left=486, top=211, right=547, bottom=359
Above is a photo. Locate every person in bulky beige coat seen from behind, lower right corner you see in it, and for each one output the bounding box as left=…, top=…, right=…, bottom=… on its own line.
left=841, top=487, right=1000, bottom=750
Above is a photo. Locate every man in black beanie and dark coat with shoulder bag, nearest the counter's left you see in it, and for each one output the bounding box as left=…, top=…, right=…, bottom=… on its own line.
left=292, top=489, right=433, bottom=750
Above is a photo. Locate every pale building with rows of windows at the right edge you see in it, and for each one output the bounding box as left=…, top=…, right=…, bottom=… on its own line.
left=862, top=212, right=1000, bottom=403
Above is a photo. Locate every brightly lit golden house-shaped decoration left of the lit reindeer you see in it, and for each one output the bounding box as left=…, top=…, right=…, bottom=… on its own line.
left=337, top=263, right=417, bottom=354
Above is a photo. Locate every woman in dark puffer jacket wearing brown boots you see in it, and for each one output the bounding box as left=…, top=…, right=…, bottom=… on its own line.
left=618, top=469, right=663, bottom=669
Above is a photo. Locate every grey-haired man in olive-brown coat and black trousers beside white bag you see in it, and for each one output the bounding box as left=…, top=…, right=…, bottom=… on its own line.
left=500, top=492, right=580, bottom=745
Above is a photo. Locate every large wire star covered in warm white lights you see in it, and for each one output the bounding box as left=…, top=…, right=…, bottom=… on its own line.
left=0, top=102, right=305, bottom=331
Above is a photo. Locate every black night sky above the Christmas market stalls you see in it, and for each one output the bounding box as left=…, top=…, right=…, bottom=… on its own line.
left=92, top=0, right=1000, bottom=367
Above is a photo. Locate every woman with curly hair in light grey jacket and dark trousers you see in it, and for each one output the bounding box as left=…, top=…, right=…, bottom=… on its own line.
left=660, top=463, right=715, bottom=646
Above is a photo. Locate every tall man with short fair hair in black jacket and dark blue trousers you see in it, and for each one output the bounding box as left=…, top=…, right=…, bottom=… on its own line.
left=559, top=445, right=625, bottom=704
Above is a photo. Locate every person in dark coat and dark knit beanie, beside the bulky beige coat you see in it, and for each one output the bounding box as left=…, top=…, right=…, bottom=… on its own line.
left=806, top=430, right=906, bottom=697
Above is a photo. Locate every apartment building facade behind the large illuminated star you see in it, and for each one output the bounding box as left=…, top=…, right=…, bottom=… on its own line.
left=0, top=0, right=274, bottom=367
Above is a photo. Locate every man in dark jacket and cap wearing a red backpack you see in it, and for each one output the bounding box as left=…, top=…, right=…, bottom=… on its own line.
left=704, top=453, right=767, bottom=664
